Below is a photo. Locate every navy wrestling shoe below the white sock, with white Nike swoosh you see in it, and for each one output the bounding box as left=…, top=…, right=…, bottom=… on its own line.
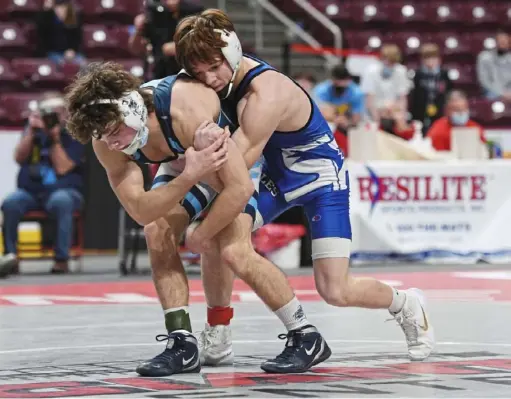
left=261, top=325, right=332, bottom=374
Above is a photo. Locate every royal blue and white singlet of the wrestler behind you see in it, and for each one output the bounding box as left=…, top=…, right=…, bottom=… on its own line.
left=222, top=55, right=351, bottom=259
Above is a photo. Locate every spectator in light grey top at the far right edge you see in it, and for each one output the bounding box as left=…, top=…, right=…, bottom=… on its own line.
left=477, top=31, right=511, bottom=101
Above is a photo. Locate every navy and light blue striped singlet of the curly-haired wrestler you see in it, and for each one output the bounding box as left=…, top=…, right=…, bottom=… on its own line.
left=133, top=73, right=259, bottom=221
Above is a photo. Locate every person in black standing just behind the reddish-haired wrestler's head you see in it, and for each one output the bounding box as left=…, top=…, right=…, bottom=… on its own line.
left=129, top=0, right=204, bottom=79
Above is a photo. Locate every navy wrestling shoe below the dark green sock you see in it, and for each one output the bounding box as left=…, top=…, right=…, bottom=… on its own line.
left=137, top=332, right=200, bottom=377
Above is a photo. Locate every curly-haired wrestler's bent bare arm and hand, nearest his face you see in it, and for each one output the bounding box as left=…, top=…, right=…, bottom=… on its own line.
left=93, top=139, right=225, bottom=225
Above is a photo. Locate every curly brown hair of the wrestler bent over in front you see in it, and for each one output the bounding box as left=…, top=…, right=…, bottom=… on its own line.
left=65, top=62, right=154, bottom=144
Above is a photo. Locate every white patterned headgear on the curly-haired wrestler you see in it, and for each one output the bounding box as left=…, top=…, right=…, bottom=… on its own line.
left=88, top=90, right=149, bottom=155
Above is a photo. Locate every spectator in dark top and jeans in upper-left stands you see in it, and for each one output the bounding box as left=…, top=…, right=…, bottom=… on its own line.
left=37, top=0, right=86, bottom=67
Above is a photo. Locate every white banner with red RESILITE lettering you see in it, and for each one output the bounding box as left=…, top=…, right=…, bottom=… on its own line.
left=348, top=160, right=511, bottom=263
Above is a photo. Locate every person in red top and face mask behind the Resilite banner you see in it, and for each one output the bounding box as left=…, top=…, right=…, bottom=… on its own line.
left=427, top=90, right=486, bottom=151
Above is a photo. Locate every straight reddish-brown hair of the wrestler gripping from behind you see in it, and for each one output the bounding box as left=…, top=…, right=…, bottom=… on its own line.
left=174, top=8, right=234, bottom=73
